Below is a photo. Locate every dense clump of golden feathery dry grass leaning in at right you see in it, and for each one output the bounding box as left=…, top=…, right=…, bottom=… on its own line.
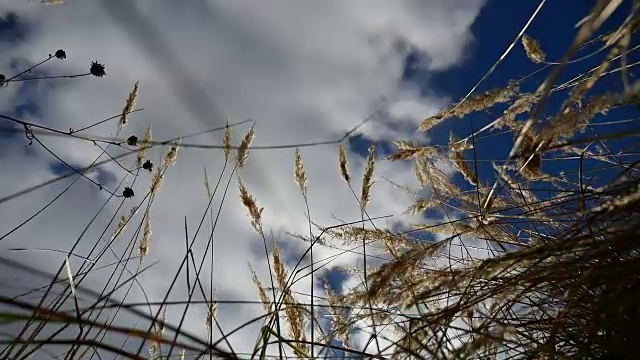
left=318, top=2, right=640, bottom=359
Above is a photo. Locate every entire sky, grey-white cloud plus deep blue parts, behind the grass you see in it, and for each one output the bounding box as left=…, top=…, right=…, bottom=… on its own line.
left=0, top=0, right=636, bottom=358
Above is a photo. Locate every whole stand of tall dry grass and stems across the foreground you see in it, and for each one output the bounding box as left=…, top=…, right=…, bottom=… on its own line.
left=0, top=1, right=640, bottom=359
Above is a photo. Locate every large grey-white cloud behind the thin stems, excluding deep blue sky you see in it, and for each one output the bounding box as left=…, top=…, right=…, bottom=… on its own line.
left=0, top=0, right=482, bottom=358
